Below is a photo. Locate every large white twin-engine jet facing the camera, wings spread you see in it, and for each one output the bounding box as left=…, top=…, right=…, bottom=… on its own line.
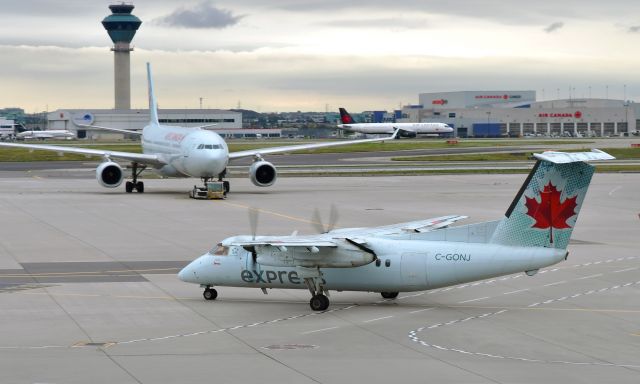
left=0, top=63, right=397, bottom=193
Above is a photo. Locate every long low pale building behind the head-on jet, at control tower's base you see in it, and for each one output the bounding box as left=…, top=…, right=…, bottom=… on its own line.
left=47, top=109, right=281, bottom=140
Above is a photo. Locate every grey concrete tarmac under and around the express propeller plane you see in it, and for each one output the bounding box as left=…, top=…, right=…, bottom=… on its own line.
left=0, top=172, right=640, bottom=383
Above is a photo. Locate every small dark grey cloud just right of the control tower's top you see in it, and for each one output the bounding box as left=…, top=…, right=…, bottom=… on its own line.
left=155, top=1, right=244, bottom=29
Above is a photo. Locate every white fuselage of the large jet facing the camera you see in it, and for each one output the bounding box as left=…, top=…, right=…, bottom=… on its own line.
left=141, top=125, right=229, bottom=178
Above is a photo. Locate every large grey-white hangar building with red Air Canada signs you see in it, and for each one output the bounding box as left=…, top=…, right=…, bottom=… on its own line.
left=400, top=90, right=640, bottom=137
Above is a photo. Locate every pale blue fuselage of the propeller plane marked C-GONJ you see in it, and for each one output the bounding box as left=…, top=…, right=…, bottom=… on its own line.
left=178, top=238, right=566, bottom=292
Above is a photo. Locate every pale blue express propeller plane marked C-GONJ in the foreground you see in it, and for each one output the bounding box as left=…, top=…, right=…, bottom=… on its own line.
left=178, top=150, right=614, bottom=311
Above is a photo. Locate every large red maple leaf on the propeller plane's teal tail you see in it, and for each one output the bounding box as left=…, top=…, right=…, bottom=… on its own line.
left=525, top=182, right=578, bottom=243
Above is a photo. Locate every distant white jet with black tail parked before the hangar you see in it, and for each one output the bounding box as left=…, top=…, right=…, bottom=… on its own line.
left=338, top=108, right=453, bottom=137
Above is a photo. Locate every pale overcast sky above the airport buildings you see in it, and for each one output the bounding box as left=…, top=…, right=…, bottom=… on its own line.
left=0, top=0, right=640, bottom=112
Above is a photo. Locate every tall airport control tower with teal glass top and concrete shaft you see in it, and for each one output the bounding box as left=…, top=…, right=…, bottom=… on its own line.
left=102, top=3, right=142, bottom=109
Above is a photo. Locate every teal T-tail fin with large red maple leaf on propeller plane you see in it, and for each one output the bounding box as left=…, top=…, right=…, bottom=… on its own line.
left=490, top=149, right=615, bottom=249
